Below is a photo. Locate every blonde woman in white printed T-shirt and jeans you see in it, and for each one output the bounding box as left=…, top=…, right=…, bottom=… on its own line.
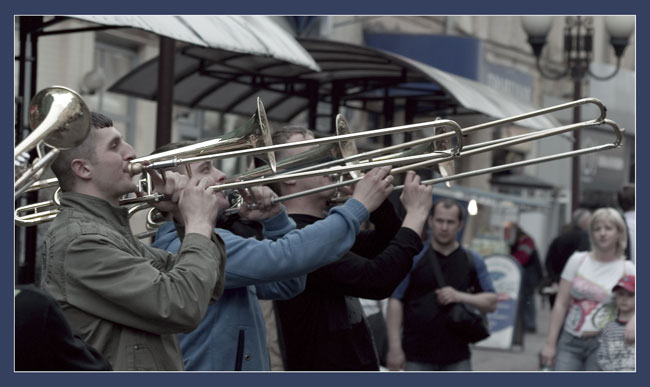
left=541, top=208, right=635, bottom=371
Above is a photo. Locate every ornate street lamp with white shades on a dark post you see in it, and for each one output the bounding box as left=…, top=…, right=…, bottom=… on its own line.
left=521, top=16, right=635, bottom=210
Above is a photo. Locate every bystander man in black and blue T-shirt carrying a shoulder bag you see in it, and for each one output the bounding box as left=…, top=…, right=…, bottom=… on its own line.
left=386, top=199, right=497, bottom=371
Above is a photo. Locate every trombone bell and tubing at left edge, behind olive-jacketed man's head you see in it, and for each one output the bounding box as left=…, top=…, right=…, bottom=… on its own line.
left=14, top=86, right=91, bottom=196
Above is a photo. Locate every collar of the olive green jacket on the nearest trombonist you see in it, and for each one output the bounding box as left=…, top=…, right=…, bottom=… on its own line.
left=61, top=192, right=130, bottom=228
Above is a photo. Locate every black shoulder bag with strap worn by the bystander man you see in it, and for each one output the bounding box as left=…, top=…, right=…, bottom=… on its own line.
left=431, top=250, right=490, bottom=343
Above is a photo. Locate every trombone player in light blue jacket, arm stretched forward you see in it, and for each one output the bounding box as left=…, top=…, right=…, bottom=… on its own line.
left=153, top=144, right=392, bottom=371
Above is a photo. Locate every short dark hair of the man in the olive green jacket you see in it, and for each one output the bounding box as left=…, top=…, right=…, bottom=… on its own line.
left=50, top=112, right=113, bottom=192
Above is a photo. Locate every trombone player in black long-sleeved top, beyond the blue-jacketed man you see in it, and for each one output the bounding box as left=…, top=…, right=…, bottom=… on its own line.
left=273, top=128, right=432, bottom=371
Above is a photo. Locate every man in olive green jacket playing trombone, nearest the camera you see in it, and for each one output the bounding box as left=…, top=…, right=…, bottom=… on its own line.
left=41, top=113, right=227, bottom=371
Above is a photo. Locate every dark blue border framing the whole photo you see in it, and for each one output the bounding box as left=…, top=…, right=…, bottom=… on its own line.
left=0, top=0, right=648, bottom=387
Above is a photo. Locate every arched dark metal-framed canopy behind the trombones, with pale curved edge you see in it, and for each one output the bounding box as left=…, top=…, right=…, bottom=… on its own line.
left=109, top=38, right=557, bottom=133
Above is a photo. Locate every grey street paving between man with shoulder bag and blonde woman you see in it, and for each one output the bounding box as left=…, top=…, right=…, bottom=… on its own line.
left=472, top=296, right=551, bottom=371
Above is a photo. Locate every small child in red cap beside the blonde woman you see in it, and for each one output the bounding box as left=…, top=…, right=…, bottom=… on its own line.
left=597, top=274, right=636, bottom=371
